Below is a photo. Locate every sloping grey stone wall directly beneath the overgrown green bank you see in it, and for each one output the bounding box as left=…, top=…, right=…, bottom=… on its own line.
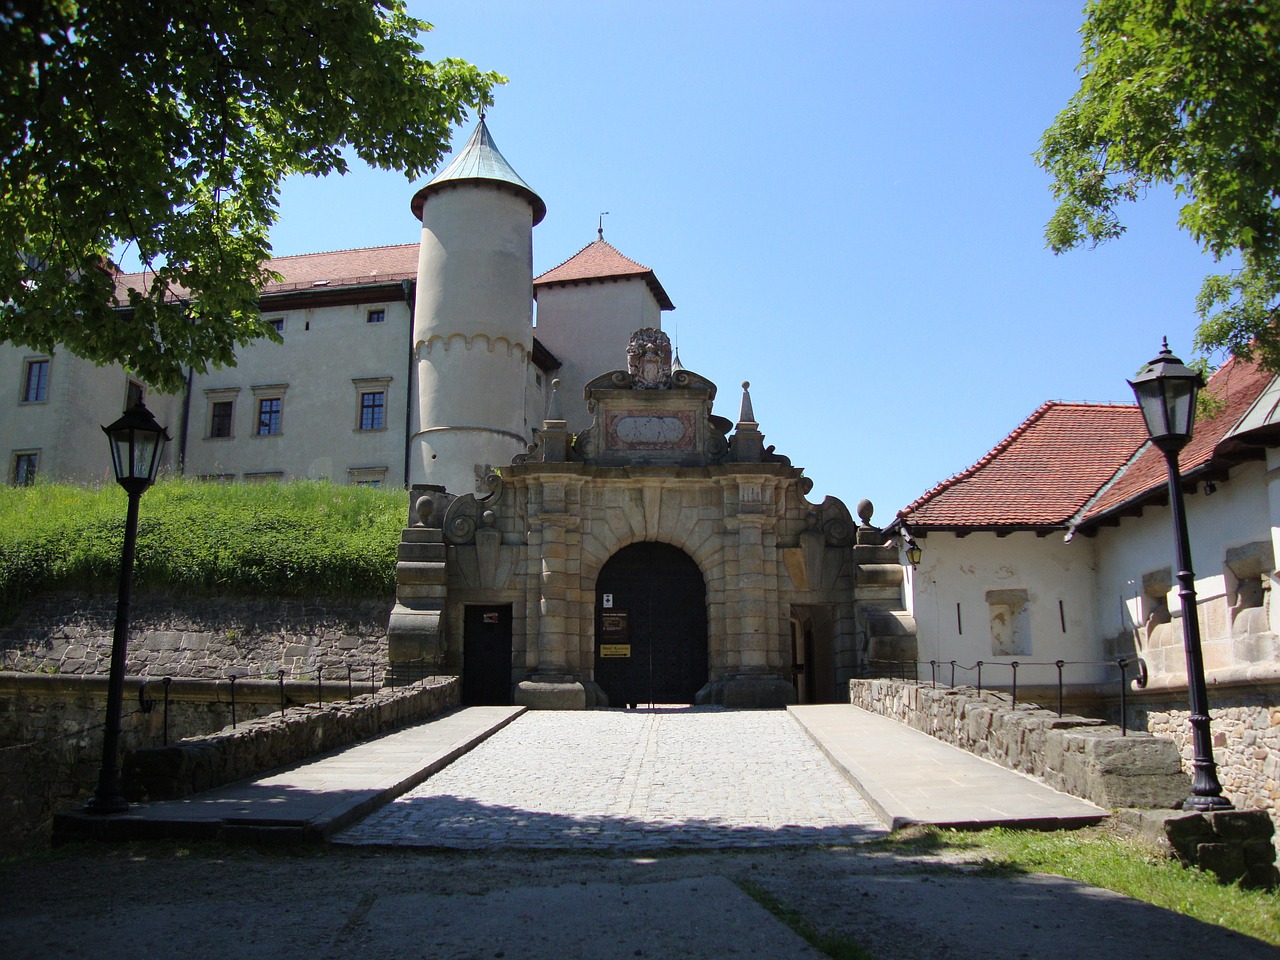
left=0, top=594, right=392, bottom=681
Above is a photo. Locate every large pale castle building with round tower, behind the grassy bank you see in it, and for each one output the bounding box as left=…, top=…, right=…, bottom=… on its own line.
left=0, top=119, right=673, bottom=494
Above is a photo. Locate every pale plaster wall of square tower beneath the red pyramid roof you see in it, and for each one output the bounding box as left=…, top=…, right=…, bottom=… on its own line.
left=538, top=278, right=662, bottom=433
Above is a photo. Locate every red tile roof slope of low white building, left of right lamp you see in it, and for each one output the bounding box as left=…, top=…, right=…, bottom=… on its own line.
left=899, top=401, right=1147, bottom=530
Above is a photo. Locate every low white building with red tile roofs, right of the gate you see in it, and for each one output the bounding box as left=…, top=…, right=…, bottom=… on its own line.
left=896, top=360, right=1280, bottom=813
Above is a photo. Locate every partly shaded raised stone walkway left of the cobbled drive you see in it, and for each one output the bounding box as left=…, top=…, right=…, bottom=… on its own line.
left=54, top=707, right=525, bottom=841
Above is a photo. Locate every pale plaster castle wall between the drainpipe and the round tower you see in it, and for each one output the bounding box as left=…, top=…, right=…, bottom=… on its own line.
left=187, top=300, right=410, bottom=486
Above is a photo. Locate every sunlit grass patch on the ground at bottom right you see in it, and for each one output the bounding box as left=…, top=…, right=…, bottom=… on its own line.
left=879, top=827, right=1280, bottom=946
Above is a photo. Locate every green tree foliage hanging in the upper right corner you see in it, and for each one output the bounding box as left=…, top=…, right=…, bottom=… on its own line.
left=1037, top=0, right=1280, bottom=371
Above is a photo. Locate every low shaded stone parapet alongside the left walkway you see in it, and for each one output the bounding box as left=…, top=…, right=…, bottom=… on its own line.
left=123, top=677, right=461, bottom=800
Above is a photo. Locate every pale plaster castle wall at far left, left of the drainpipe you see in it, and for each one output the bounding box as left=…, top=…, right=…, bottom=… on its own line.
left=0, top=343, right=182, bottom=483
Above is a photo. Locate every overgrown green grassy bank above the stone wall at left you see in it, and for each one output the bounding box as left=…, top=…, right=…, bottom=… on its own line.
left=0, top=480, right=406, bottom=617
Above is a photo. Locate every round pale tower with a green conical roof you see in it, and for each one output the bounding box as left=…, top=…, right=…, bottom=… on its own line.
left=408, top=115, right=547, bottom=495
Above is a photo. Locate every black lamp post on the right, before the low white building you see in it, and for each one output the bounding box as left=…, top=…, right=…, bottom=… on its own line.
left=1129, top=339, right=1231, bottom=813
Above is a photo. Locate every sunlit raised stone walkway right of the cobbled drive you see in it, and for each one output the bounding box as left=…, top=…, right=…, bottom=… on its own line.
left=787, top=704, right=1108, bottom=829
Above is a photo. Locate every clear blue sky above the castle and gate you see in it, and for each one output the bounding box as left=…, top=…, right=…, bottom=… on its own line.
left=273, top=0, right=1213, bottom=524
